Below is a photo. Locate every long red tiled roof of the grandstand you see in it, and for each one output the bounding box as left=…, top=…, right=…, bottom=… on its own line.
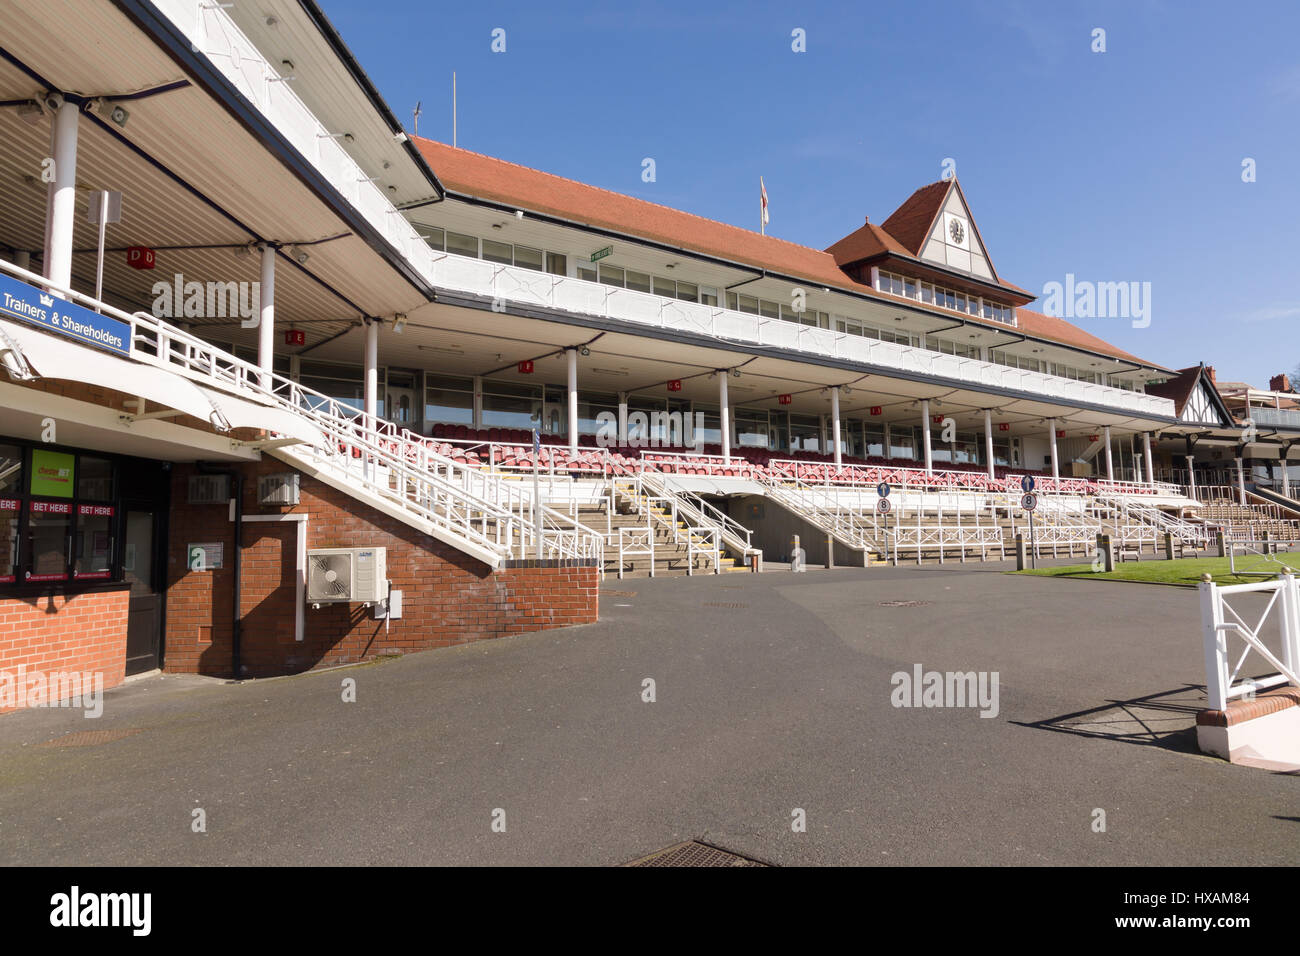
left=413, top=137, right=1158, bottom=368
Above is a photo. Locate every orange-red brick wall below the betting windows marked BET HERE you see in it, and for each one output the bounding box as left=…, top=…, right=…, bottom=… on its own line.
left=0, top=588, right=130, bottom=713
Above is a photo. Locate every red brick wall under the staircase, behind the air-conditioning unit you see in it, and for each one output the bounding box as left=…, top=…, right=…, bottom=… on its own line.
left=164, top=455, right=599, bottom=676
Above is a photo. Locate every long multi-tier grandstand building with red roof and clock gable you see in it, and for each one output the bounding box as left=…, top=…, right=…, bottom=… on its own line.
left=0, top=0, right=1300, bottom=702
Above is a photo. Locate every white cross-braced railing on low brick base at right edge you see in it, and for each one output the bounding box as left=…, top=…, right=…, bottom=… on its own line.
left=1200, top=574, right=1300, bottom=710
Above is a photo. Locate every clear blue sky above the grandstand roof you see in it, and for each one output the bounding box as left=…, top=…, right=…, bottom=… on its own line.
left=322, top=0, right=1300, bottom=386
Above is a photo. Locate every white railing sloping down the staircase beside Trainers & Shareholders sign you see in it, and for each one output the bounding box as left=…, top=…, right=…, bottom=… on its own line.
left=0, top=260, right=602, bottom=566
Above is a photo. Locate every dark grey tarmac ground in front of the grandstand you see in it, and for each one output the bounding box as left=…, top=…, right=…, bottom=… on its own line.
left=0, top=564, right=1300, bottom=865
